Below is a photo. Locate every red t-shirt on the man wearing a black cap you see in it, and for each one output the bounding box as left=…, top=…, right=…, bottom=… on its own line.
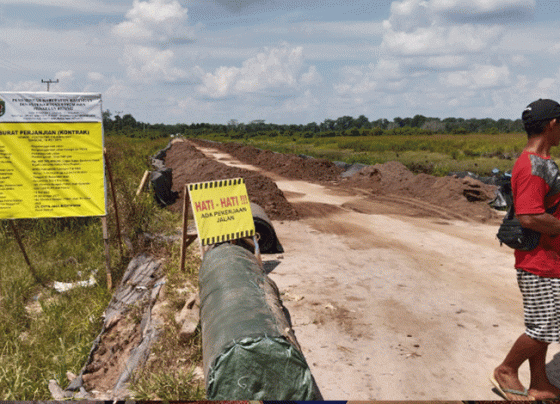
left=511, top=152, right=560, bottom=278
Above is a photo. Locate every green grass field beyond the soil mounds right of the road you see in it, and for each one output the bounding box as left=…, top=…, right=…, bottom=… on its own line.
left=197, top=134, right=532, bottom=176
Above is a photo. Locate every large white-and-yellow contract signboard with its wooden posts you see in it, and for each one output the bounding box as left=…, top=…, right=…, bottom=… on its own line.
left=0, top=92, right=118, bottom=288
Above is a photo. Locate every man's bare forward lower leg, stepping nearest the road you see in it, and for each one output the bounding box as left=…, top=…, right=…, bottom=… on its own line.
left=494, top=334, right=548, bottom=400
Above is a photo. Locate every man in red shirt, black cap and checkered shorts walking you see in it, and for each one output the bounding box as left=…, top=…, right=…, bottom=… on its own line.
left=490, top=99, right=560, bottom=400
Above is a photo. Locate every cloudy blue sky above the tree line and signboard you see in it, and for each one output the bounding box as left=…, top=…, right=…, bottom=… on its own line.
left=0, top=0, right=560, bottom=124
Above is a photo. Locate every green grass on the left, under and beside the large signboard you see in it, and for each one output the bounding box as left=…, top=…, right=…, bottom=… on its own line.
left=0, top=136, right=198, bottom=401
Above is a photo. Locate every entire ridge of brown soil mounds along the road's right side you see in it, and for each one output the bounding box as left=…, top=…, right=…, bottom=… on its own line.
left=190, top=139, right=499, bottom=222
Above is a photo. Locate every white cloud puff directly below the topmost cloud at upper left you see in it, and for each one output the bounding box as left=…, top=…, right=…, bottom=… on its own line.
left=123, top=45, right=189, bottom=82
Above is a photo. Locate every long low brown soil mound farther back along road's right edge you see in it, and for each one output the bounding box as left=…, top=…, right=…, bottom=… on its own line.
left=191, top=139, right=344, bottom=182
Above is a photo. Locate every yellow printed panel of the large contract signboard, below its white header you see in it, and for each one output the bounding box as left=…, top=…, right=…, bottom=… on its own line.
left=0, top=122, right=106, bottom=219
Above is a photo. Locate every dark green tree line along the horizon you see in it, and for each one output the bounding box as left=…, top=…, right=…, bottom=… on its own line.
left=103, top=110, right=524, bottom=139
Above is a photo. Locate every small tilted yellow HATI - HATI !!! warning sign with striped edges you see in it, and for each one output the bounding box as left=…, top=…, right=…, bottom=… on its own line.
left=188, top=178, right=255, bottom=245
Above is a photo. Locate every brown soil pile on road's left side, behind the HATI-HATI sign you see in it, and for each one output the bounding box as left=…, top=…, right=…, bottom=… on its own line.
left=165, top=141, right=298, bottom=220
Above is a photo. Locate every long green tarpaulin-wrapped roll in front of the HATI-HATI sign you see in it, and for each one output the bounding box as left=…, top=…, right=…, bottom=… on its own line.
left=199, top=244, right=322, bottom=401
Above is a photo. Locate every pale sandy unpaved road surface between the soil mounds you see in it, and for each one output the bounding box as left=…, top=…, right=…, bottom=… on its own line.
left=190, top=143, right=560, bottom=400
